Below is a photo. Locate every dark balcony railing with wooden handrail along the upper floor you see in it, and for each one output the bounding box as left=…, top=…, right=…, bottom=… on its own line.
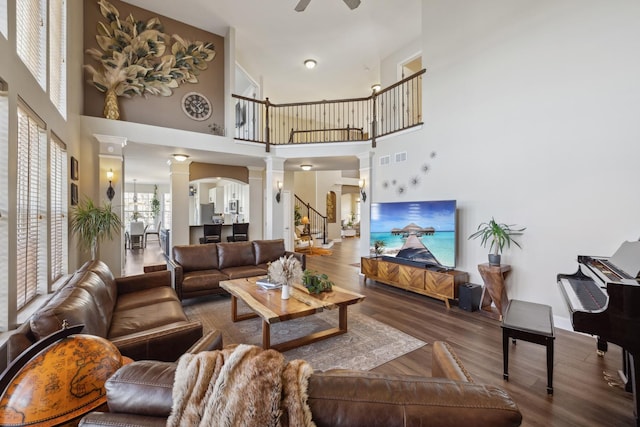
left=232, top=70, right=425, bottom=151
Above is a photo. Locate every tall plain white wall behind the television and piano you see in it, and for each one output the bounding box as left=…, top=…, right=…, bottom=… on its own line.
left=372, top=0, right=640, bottom=327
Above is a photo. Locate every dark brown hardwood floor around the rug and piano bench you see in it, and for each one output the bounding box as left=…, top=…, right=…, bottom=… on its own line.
left=126, top=239, right=635, bottom=426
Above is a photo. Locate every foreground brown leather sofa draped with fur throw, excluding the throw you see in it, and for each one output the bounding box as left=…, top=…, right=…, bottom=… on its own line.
left=80, top=342, right=522, bottom=427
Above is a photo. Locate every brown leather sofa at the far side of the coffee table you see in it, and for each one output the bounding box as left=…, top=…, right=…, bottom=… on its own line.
left=167, top=239, right=307, bottom=300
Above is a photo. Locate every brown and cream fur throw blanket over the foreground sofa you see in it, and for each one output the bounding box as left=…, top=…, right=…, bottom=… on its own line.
left=167, top=344, right=315, bottom=427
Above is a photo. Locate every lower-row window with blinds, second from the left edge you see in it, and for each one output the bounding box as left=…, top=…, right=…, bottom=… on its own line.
left=16, top=107, right=48, bottom=309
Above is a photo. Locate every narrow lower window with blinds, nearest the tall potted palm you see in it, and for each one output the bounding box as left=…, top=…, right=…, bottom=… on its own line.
left=49, top=136, right=69, bottom=283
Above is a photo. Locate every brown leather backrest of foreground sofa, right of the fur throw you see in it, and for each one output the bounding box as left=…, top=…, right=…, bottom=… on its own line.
left=308, top=370, right=522, bottom=427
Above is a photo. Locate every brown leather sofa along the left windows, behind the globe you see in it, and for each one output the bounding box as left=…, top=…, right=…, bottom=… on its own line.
left=7, top=260, right=222, bottom=362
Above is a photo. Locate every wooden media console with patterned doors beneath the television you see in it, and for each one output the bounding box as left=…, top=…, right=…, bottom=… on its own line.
left=360, top=257, right=469, bottom=308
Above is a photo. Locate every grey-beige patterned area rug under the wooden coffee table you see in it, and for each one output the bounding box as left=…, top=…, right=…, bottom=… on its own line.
left=184, top=296, right=426, bottom=371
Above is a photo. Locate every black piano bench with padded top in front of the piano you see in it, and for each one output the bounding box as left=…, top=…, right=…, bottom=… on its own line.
left=502, top=300, right=555, bottom=394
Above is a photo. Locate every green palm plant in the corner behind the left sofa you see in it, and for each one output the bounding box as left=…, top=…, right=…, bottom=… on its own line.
left=70, top=198, right=122, bottom=259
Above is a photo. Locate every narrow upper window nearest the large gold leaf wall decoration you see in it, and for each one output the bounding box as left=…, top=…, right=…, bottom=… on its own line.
left=49, top=0, right=67, bottom=119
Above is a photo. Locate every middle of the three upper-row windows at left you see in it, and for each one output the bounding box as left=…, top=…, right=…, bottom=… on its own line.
left=16, top=0, right=47, bottom=89
